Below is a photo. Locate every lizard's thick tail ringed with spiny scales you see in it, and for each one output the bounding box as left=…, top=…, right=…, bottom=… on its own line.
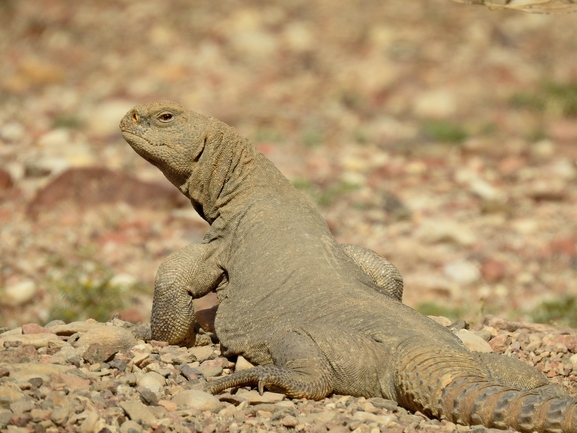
left=396, top=344, right=577, bottom=433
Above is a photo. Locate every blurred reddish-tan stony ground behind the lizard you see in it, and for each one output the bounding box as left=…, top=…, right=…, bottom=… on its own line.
left=0, top=0, right=577, bottom=327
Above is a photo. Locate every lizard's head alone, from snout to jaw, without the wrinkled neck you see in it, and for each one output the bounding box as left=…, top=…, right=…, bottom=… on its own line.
left=120, top=101, right=212, bottom=188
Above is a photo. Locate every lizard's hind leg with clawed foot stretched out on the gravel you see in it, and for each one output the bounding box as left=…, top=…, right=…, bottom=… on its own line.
left=205, top=323, right=393, bottom=400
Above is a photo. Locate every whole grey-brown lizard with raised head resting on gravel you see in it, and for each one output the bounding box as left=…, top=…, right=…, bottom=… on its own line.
left=120, top=101, right=577, bottom=432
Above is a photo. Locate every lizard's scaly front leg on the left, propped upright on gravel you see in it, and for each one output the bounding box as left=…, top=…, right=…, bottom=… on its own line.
left=151, top=243, right=226, bottom=347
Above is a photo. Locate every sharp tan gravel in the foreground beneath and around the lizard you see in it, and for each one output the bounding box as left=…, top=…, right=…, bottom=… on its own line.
left=0, top=317, right=577, bottom=433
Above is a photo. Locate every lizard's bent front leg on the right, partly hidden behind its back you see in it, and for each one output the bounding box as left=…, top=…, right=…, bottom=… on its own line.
left=341, top=244, right=403, bottom=302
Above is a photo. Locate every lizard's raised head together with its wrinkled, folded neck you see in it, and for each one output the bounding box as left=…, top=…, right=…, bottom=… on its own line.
left=120, top=101, right=256, bottom=224
